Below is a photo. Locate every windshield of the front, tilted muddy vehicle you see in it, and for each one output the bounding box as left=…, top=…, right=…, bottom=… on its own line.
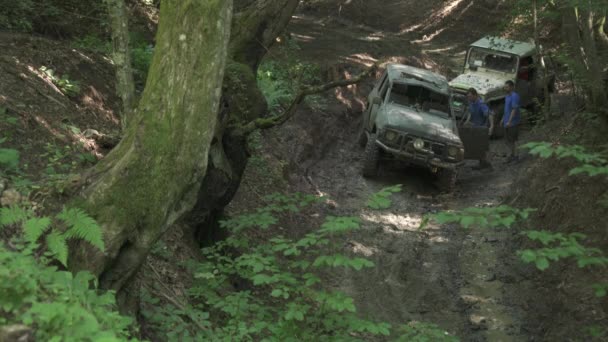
left=387, top=83, right=450, bottom=118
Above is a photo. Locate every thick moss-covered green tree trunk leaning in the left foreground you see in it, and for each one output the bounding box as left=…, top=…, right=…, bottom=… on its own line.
left=72, top=0, right=232, bottom=290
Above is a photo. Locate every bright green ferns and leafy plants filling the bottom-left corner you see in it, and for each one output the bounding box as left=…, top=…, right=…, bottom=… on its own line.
left=0, top=207, right=133, bottom=341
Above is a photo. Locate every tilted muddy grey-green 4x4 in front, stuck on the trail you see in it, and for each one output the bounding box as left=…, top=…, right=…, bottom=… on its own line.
left=359, top=64, right=464, bottom=190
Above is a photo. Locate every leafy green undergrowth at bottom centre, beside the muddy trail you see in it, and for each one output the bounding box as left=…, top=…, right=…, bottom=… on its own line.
left=144, top=189, right=455, bottom=341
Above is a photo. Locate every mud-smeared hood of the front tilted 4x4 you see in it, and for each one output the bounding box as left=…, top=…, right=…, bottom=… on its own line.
left=377, top=104, right=462, bottom=145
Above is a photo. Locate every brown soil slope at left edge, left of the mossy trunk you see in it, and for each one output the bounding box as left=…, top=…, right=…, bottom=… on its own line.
left=0, top=33, right=119, bottom=200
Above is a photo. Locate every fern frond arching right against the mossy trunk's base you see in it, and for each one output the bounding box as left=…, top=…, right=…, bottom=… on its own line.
left=57, top=208, right=105, bottom=251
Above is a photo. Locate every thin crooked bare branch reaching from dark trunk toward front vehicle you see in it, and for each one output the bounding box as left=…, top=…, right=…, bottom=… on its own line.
left=231, top=64, right=378, bottom=136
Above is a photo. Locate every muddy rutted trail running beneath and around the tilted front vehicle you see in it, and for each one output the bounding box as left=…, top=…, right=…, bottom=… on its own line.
left=256, top=8, right=530, bottom=341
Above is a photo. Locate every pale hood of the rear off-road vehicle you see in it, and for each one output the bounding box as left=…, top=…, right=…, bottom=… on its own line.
left=450, top=72, right=509, bottom=99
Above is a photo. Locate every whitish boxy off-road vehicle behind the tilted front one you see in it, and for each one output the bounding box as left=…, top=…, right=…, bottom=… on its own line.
left=450, top=37, right=555, bottom=133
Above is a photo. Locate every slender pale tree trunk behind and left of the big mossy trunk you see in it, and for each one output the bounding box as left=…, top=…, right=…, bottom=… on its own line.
left=105, top=0, right=135, bottom=131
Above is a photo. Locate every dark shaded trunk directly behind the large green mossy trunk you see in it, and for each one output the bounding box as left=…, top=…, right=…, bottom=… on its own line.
left=188, top=0, right=298, bottom=242
